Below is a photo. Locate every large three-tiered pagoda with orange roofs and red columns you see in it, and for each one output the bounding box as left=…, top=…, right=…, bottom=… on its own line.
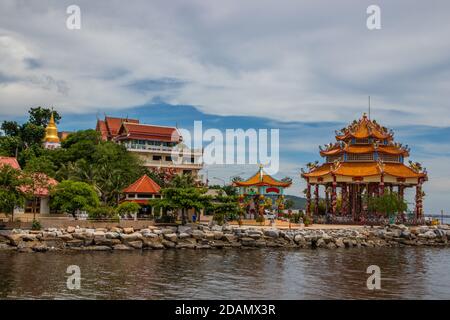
left=301, top=114, right=427, bottom=221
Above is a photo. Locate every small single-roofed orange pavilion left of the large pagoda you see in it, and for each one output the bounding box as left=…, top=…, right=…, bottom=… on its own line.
left=233, top=165, right=292, bottom=219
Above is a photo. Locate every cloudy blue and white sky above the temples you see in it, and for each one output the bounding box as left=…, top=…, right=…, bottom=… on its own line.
left=0, top=0, right=450, bottom=213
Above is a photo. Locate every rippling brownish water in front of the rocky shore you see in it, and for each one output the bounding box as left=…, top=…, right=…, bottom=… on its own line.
left=0, top=247, right=450, bottom=299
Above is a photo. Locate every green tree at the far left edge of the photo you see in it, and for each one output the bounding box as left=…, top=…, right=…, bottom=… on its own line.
left=0, top=165, right=27, bottom=220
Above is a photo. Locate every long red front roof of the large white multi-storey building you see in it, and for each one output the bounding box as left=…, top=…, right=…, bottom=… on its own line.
left=117, top=122, right=181, bottom=142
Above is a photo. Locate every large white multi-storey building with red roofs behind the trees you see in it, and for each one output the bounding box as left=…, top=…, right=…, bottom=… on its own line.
left=96, top=117, right=203, bottom=177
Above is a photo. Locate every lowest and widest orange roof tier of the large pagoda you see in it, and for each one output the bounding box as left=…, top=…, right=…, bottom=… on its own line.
left=302, top=162, right=426, bottom=178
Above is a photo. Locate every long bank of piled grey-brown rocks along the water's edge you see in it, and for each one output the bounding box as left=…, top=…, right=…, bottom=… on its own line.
left=0, top=225, right=450, bottom=252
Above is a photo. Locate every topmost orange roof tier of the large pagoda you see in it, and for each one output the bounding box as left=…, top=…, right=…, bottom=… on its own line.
left=336, top=114, right=392, bottom=141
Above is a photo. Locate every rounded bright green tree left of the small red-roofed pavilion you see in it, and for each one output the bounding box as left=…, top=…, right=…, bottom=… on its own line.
left=50, top=180, right=100, bottom=217
